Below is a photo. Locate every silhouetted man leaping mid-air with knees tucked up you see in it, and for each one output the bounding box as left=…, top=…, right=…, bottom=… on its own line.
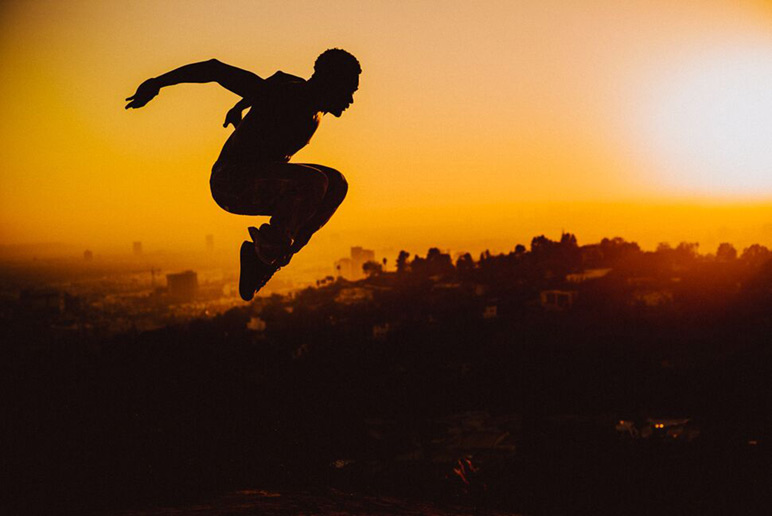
left=126, top=49, right=362, bottom=301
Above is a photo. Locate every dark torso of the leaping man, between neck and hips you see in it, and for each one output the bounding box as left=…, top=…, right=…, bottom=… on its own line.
left=218, top=72, right=321, bottom=165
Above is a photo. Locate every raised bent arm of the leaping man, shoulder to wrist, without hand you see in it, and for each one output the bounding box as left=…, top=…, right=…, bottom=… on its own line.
left=154, top=59, right=264, bottom=98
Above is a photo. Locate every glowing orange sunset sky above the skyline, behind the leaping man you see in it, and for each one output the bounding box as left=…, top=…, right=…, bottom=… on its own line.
left=0, top=0, right=772, bottom=255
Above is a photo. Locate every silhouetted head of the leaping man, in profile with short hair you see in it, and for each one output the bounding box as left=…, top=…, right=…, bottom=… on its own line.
left=311, top=48, right=362, bottom=116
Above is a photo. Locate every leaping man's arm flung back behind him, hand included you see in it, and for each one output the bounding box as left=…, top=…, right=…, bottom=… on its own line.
left=126, top=59, right=264, bottom=109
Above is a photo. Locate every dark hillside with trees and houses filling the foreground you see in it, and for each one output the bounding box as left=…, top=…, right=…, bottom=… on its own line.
left=0, top=235, right=772, bottom=515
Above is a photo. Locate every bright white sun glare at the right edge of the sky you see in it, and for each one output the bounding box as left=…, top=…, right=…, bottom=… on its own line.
left=643, top=48, right=772, bottom=199
